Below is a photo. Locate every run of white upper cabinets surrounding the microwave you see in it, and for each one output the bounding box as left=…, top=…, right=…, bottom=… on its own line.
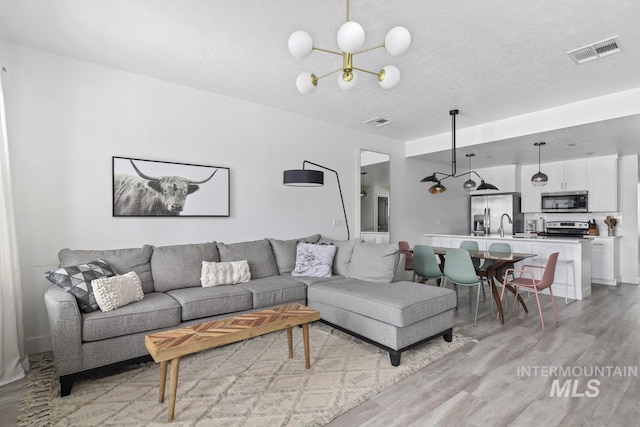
left=520, top=156, right=618, bottom=213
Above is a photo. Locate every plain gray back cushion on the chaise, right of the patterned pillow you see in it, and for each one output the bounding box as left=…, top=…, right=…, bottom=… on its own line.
left=345, top=242, right=398, bottom=283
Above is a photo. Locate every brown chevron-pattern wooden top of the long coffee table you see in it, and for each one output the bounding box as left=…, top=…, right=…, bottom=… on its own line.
left=145, top=304, right=320, bottom=363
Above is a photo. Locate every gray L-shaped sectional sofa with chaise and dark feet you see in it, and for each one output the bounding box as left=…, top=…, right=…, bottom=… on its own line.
left=45, top=235, right=456, bottom=396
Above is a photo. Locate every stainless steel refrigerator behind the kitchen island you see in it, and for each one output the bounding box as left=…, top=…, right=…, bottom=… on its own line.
left=471, top=193, right=524, bottom=236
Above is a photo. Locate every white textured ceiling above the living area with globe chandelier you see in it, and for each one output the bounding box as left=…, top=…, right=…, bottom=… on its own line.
left=0, top=0, right=640, bottom=166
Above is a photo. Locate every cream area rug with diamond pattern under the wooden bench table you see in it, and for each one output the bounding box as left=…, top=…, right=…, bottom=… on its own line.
left=18, top=323, right=474, bottom=427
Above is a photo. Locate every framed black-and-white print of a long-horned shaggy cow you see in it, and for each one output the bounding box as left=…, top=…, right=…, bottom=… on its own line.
left=112, top=156, right=230, bottom=217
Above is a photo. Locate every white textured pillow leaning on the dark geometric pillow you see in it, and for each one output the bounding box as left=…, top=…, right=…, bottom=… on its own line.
left=91, top=271, right=144, bottom=311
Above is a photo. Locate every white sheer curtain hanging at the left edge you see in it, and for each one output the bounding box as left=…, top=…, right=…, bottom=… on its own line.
left=0, top=69, right=29, bottom=386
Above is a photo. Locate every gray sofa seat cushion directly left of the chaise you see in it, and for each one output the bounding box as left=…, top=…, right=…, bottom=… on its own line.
left=234, top=276, right=307, bottom=308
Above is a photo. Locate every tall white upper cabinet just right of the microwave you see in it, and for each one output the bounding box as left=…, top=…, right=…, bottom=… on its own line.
left=586, top=156, right=618, bottom=212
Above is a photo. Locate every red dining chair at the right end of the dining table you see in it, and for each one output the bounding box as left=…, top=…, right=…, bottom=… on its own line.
left=500, top=252, right=558, bottom=331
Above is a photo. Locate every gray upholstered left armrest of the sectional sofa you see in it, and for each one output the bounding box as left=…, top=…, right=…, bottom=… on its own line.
left=44, top=285, right=83, bottom=375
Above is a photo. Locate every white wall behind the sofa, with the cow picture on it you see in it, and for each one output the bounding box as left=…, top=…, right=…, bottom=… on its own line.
left=0, top=42, right=440, bottom=353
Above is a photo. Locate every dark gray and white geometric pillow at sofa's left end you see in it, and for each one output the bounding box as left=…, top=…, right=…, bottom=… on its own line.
left=44, top=259, right=115, bottom=313
